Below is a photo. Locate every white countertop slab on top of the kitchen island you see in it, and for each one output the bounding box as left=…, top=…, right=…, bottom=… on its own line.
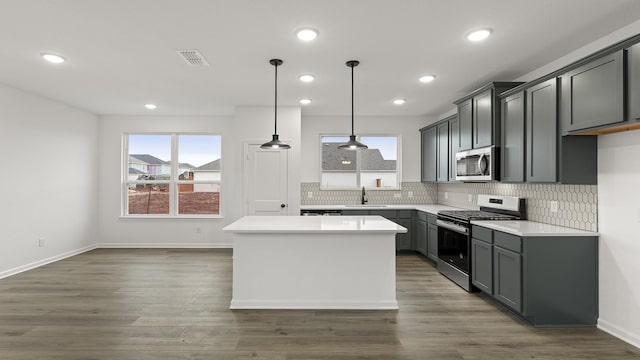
left=222, top=216, right=407, bottom=234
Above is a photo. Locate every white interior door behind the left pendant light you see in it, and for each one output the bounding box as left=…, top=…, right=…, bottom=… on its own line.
left=246, top=144, right=289, bottom=215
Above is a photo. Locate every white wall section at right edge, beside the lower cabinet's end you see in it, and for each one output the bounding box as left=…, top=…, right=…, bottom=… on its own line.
left=598, top=131, right=640, bottom=347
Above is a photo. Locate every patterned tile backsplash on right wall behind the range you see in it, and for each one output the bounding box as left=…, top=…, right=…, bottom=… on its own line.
left=438, top=183, right=598, bottom=231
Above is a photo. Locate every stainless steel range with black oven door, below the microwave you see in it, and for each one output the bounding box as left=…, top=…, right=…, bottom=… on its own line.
left=437, top=195, right=527, bottom=291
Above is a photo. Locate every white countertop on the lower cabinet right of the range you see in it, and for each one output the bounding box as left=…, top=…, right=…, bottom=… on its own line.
left=471, top=220, right=598, bottom=237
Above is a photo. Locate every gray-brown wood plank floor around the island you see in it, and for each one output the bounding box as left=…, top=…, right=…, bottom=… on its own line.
left=0, top=249, right=640, bottom=360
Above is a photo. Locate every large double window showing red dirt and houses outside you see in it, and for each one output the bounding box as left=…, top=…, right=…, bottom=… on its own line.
left=122, top=134, right=222, bottom=216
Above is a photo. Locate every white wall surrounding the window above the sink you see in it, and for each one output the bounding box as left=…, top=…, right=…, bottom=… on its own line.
left=300, top=116, right=433, bottom=182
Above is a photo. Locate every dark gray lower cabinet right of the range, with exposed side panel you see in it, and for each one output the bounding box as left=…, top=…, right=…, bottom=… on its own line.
left=471, top=225, right=598, bottom=326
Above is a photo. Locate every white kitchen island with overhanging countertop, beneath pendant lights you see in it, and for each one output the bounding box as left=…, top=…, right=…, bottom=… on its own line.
left=223, top=216, right=407, bottom=310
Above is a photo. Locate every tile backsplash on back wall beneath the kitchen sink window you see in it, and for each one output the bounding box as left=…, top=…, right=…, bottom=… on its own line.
left=300, top=182, right=438, bottom=205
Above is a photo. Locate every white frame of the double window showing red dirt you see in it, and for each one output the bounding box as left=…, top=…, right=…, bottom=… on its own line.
left=120, top=131, right=224, bottom=219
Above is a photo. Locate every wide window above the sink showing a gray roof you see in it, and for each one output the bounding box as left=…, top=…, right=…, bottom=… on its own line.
left=320, top=136, right=400, bottom=190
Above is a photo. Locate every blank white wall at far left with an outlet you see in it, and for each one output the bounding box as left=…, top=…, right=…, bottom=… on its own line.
left=0, top=85, right=98, bottom=278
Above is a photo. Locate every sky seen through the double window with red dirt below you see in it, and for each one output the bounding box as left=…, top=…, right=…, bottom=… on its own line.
left=129, top=135, right=222, bottom=167
